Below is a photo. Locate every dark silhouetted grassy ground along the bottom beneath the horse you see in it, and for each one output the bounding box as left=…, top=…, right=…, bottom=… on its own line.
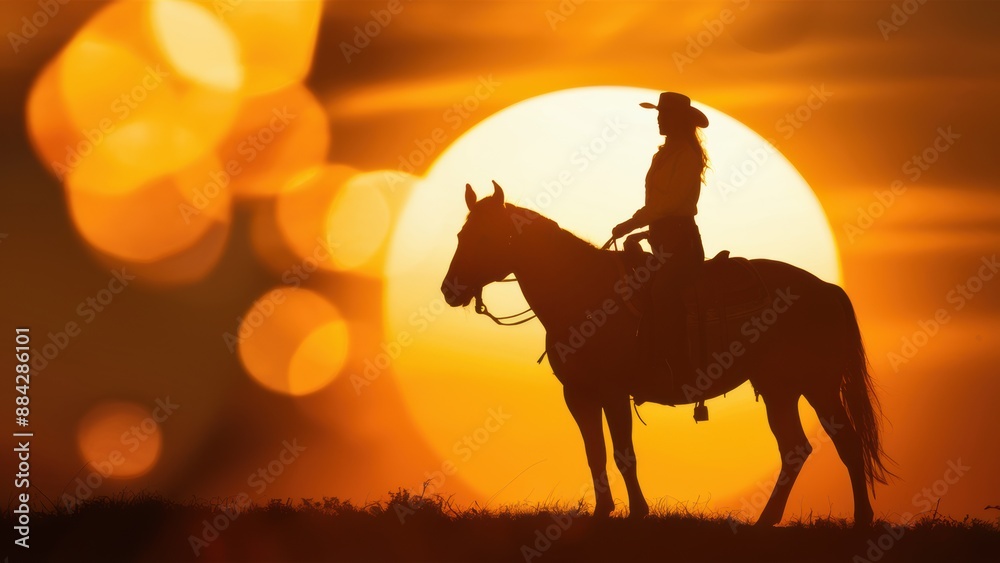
left=3, top=491, right=1000, bottom=563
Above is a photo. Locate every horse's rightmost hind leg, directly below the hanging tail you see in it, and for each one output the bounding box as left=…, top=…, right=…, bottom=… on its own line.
left=806, top=388, right=875, bottom=526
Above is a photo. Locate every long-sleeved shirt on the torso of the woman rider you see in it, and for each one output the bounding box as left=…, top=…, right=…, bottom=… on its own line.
left=633, top=141, right=702, bottom=227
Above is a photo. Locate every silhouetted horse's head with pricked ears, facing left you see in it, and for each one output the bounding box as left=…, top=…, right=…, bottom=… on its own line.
left=441, top=182, right=515, bottom=307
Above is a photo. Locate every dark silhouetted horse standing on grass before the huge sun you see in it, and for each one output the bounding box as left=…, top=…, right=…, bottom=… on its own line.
left=441, top=182, right=892, bottom=526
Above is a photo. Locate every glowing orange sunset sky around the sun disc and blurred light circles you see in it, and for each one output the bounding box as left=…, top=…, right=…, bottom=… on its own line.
left=0, top=0, right=1000, bottom=518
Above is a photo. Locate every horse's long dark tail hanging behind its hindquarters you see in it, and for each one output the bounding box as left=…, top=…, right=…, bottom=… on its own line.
left=837, top=287, right=895, bottom=496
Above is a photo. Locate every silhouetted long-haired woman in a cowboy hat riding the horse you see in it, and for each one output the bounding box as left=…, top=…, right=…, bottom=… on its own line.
left=611, top=92, right=708, bottom=382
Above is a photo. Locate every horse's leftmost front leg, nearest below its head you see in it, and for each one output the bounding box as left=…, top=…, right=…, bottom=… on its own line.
left=563, top=385, right=615, bottom=517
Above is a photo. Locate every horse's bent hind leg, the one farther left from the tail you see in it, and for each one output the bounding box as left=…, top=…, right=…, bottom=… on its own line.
left=757, top=393, right=812, bottom=526
